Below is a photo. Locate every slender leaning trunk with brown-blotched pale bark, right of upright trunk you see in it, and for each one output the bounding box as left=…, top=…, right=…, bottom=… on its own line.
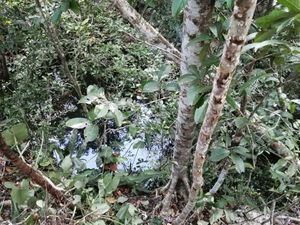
left=174, top=0, right=256, bottom=225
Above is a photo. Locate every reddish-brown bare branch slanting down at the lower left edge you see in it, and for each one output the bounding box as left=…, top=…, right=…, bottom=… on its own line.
left=0, top=135, right=67, bottom=203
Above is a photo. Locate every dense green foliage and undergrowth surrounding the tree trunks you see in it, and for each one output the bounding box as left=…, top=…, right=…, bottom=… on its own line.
left=0, top=0, right=300, bottom=225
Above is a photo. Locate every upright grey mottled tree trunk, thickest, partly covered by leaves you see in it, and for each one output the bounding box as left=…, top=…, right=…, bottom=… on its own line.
left=161, top=0, right=214, bottom=215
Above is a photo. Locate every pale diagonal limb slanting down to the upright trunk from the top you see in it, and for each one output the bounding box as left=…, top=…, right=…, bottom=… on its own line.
left=112, top=0, right=181, bottom=64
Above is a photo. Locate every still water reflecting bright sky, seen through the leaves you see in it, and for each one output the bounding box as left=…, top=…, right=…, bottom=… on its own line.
left=50, top=105, right=172, bottom=172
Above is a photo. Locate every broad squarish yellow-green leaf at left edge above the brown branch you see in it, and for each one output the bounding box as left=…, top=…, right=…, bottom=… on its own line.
left=1, top=123, right=29, bottom=146
